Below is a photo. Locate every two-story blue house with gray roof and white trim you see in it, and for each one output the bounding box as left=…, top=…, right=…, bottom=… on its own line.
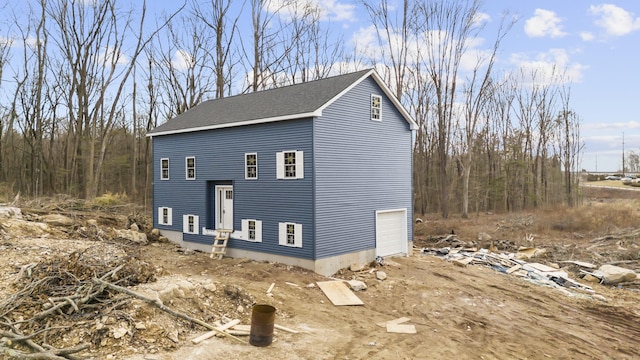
left=148, top=70, right=416, bottom=275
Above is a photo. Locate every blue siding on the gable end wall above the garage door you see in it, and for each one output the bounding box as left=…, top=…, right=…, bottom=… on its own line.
left=314, top=78, right=413, bottom=259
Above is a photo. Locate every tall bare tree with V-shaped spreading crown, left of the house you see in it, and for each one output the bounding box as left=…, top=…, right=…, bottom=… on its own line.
left=46, top=0, right=178, bottom=198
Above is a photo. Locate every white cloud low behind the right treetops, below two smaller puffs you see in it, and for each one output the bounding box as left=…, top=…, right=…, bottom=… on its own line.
left=511, top=49, right=588, bottom=84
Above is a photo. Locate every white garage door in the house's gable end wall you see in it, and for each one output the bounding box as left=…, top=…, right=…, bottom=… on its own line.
left=376, top=209, right=407, bottom=256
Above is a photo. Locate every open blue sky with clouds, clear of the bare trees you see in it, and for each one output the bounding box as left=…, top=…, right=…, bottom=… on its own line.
left=129, top=0, right=640, bottom=172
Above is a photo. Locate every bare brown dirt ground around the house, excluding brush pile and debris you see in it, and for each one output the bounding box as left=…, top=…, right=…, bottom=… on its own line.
left=0, top=188, right=640, bottom=360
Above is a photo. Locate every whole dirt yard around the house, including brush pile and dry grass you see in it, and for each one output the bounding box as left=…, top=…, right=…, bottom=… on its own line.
left=0, top=188, right=640, bottom=360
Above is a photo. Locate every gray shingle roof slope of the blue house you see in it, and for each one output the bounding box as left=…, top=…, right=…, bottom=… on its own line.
left=147, top=69, right=372, bottom=136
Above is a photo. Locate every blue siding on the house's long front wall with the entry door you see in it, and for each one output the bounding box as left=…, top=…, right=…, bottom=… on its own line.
left=153, top=119, right=315, bottom=259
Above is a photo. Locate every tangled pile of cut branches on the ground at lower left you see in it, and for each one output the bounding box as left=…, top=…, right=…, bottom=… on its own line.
left=0, top=251, right=155, bottom=359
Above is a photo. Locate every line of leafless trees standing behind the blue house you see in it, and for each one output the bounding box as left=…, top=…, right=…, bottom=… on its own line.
left=0, top=0, right=581, bottom=217
